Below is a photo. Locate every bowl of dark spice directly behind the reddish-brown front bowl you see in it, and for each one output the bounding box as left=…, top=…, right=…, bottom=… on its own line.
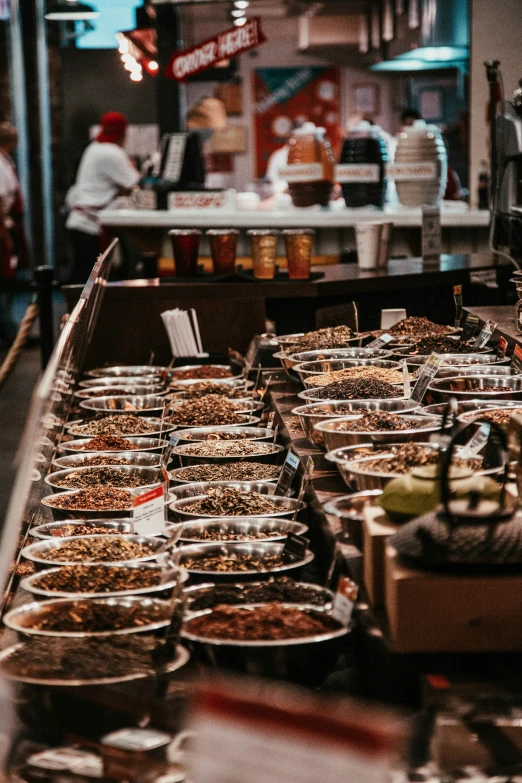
left=184, top=576, right=334, bottom=612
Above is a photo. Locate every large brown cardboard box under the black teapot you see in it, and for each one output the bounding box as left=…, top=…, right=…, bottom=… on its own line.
left=385, top=545, right=522, bottom=653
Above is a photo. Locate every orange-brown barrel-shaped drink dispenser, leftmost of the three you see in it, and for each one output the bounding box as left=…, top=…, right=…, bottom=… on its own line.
left=288, top=122, right=335, bottom=207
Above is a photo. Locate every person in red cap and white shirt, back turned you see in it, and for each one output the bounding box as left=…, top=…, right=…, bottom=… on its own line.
left=66, top=111, right=140, bottom=283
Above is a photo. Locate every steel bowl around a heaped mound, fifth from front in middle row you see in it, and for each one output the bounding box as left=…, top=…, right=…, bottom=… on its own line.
left=169, top=481, right=306, bottom=522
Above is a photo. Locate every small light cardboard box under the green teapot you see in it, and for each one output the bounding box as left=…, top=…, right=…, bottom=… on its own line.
left=363, top=506, right=399, bottom=609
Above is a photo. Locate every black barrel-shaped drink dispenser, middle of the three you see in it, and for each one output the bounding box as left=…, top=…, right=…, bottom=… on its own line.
left=339, top=121, right=388, bottom=209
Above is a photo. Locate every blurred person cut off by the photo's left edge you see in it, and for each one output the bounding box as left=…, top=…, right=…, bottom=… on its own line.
left=0, top=122, right=29, bottom=346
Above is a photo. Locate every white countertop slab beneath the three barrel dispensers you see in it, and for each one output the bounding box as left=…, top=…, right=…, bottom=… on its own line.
left=100, top=202, right=489, bottom=230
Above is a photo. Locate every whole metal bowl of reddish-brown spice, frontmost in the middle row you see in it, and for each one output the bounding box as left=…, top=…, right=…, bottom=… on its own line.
left=181, top=603, right=349, bottom=686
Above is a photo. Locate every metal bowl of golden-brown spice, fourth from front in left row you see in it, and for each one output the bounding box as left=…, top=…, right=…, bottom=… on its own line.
left=22, top=534, right=163, bottom=570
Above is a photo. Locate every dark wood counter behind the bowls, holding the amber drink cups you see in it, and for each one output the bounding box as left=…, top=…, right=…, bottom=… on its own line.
left=64, top=254, right=511, bottom=367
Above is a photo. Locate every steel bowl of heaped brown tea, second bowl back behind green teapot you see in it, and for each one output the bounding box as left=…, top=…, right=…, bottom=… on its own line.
left=315, top=414, right=442, bottom=451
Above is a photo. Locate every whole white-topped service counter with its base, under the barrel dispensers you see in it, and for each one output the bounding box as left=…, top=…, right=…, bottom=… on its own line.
left=100, top=202, right=489, bottom=257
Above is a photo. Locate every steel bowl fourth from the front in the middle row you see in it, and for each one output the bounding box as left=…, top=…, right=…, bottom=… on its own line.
left=179, top=517, right=308, bottom=544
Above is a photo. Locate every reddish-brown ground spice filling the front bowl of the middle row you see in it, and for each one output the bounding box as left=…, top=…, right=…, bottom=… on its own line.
left=185, top=603, right=342, bottom=641
